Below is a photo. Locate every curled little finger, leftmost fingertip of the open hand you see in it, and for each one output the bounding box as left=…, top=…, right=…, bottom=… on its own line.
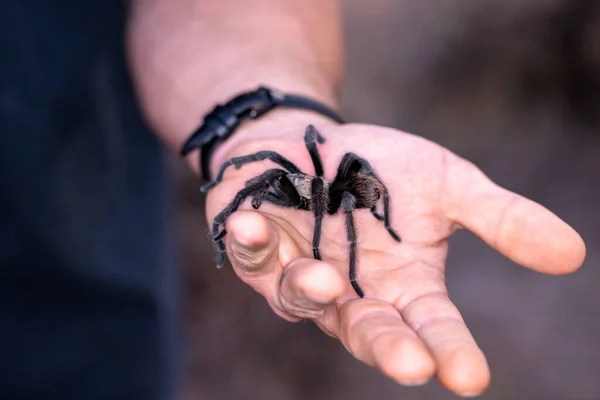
left=227, top=210, right=279, bottom=281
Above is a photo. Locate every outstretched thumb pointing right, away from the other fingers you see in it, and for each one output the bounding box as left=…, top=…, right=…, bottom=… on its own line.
left=446, top=160, right=585, bottom=274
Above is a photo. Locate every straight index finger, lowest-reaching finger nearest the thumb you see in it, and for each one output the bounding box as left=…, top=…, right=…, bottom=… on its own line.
left=402, top=293, right=490, bottom=396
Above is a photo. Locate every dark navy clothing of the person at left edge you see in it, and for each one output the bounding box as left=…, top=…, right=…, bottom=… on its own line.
left=0, top=0, right=178, bottom=400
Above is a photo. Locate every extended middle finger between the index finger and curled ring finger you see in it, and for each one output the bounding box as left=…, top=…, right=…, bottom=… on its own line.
left=332, top=299, right=435, bottom=385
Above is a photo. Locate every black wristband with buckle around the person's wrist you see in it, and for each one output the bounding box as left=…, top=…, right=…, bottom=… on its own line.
left=181, top=87, right=345, bottom=181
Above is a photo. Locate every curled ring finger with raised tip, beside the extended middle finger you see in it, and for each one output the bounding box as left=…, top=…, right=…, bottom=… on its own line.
left=279, top=258, right=350, bottom=320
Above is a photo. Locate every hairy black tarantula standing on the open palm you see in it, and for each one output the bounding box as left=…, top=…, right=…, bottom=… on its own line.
left=200, top=125, right=400, bottom=297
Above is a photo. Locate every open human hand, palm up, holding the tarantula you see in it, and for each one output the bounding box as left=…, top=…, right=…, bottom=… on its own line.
left=202, top=115, right=585, bottom=395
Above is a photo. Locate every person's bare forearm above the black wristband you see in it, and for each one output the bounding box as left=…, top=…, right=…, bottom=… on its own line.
left=128, top=0, right=342, bottom=172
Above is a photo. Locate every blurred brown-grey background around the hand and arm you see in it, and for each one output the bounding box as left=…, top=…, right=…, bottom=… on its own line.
left=177, top=0, right=600, bottom=400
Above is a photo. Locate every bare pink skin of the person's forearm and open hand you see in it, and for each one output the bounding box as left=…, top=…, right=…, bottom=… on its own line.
left=128, top=0, right=585, bottom=396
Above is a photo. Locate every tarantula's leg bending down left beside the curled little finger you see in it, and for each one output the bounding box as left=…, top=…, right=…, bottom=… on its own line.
left=211, top=169, right=287, bottom=268
